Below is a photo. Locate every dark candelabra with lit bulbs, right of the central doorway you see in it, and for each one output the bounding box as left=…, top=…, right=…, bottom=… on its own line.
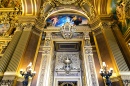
left=100, top=62, right=113, bottom=86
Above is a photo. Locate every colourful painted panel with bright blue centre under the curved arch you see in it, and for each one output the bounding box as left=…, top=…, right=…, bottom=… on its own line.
left=46, top=15, right=88, bottom=27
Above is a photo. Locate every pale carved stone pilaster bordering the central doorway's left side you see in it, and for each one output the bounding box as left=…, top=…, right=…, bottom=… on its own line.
left=36, top=33, right=54, bottom=86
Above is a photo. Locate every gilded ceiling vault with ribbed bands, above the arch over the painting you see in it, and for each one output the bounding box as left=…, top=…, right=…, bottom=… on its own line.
left=21, top=0, right=115, bottom=16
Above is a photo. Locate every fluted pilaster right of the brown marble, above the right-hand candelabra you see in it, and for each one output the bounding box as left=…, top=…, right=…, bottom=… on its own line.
left=104, top=28, right=129, bottom=71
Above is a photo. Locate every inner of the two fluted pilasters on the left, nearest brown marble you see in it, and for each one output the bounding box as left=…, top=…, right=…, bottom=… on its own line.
left=6, top=29, right=31, bottom=72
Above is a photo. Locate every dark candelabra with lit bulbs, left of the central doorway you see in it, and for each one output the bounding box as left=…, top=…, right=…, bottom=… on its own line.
left=20, top=62, right=36, bottom=86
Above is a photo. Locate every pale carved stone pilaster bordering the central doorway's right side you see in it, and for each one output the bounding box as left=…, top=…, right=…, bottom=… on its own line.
left=82, top=32, right=99, bottom=86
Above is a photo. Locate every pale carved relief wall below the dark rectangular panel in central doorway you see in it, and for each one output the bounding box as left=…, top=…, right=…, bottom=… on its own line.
left=53, top=52, right=82, bottom=86
